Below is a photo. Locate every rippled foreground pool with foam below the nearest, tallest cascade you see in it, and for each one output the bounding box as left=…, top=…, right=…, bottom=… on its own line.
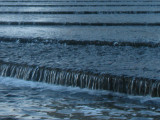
left=0, top=77, right=160, bottom=120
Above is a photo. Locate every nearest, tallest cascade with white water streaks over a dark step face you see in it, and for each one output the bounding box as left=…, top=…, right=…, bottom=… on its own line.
left=0, top=61, right=160, bottom=97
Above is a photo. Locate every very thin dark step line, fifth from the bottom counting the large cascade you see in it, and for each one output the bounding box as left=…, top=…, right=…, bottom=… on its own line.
left=0, top=4, right=160, bottom=7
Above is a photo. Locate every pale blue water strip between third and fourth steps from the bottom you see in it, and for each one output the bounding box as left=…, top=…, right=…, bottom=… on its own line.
left=0, top=14, right=160, bottom=24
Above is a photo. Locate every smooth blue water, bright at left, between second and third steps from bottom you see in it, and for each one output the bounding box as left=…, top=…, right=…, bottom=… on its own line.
left=0, top=25, right=160, bottom=43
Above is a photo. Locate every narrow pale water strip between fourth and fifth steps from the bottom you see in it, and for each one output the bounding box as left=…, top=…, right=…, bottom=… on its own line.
left=0, top=6, right=160, bottom=12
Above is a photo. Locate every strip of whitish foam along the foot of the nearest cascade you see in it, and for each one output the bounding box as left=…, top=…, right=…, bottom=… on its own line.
left=0, top=77, right=160, bottom=103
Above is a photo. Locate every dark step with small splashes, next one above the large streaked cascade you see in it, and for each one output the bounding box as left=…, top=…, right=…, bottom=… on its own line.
left=0, top=37, right=160, bottom=48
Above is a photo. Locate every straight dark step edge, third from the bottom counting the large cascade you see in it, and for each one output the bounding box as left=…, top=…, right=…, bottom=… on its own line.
left=0, top=21, right=160, bottom=26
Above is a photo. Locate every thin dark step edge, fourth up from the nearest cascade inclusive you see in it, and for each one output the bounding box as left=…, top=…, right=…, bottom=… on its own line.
left=0, top=11, right=160, bottom=14
